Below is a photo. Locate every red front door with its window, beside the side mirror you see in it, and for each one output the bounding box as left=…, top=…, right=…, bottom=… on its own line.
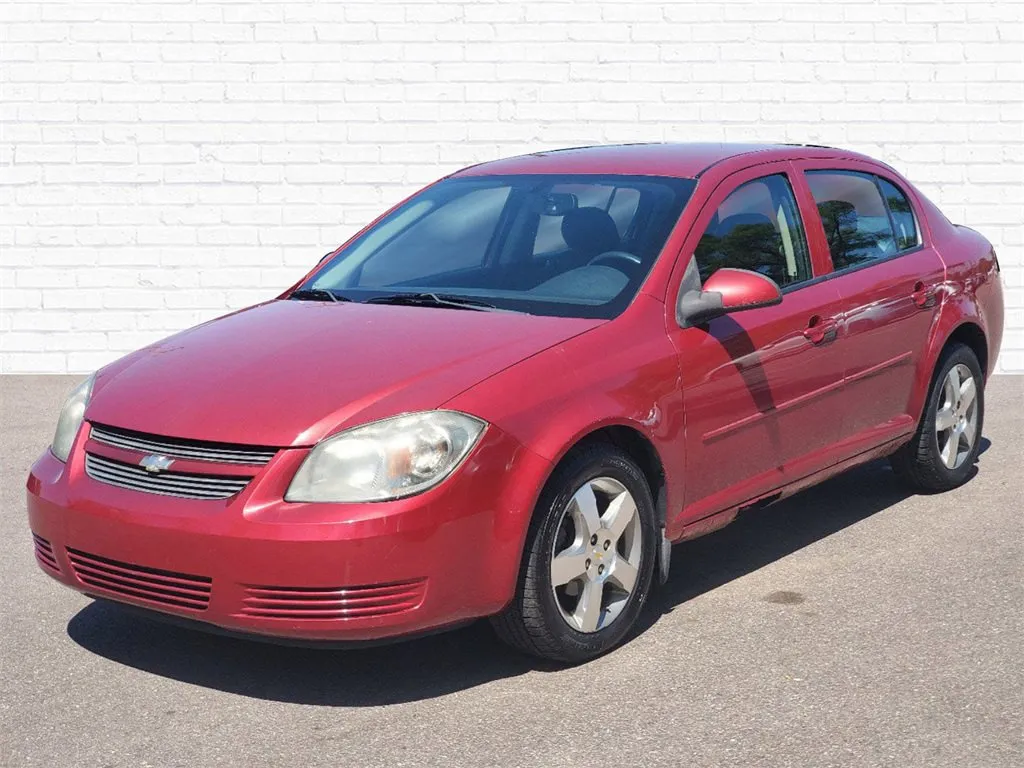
left=670, top=163, right=844, bottom=523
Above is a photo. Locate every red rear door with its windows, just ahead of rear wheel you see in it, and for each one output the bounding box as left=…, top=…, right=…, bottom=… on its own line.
left=800, top=161, right=945, bottom=456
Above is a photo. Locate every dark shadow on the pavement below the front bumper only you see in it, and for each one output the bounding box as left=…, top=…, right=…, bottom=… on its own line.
left=68, top=601, right=537, bottom=707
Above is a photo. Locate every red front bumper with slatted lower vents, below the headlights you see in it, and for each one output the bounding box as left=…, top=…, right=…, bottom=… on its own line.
left=28, top=426, right=550, bottom=642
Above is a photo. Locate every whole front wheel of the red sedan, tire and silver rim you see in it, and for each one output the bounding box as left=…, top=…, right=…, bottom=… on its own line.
left=492, top=442, right=658, bottom=664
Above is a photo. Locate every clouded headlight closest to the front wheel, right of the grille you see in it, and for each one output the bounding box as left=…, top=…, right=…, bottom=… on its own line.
left=285, top=411, right=486, bottom=502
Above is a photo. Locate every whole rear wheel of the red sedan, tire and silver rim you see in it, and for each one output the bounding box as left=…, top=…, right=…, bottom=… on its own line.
left=890, top=343, right=985, bottom=494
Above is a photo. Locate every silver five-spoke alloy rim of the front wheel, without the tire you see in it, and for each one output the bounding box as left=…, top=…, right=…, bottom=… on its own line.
left=551, top=477, right=643, bottom=633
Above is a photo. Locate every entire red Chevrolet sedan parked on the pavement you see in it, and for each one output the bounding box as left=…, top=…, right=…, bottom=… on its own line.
left=28, top=144, right=1004, bottom=662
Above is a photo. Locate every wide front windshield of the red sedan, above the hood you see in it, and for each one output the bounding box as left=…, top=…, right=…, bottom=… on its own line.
left=301, top=174, right=696, bottom=317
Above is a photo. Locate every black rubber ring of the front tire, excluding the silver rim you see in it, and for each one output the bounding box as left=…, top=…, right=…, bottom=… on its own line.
left=530, top=444, right=657, bottom=662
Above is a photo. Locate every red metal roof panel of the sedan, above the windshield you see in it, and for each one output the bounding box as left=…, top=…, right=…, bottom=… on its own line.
left=455, top=143, right=868, bottom=178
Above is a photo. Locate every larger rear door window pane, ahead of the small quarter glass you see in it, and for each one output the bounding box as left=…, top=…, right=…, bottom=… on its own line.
left=806, top=171, right=897, bottom=269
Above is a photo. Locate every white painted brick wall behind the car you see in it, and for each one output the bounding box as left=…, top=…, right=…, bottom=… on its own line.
left=0, top=0, right=1024, bottom=373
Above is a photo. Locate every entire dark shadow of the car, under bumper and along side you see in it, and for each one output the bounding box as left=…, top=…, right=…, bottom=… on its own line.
left=68, top=454, right=987, bottom=707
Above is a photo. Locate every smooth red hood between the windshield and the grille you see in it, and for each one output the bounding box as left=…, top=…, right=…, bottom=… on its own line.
left=86, top=300, right=604, bottom=446
